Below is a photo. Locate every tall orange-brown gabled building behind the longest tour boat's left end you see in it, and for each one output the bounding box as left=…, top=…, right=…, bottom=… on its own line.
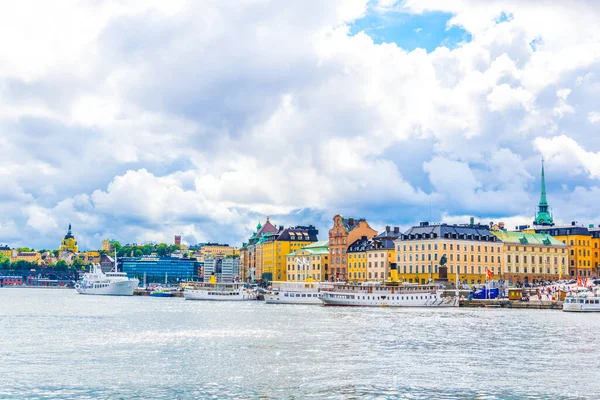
left=329, top=214, right=377, bottom=281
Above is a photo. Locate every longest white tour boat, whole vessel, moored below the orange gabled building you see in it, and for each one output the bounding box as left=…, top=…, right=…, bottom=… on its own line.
left=320, top=283, right=459, bottom=307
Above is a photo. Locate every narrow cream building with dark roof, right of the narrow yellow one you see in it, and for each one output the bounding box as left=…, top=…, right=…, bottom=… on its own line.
left=367, top=226, right=401, bottom=281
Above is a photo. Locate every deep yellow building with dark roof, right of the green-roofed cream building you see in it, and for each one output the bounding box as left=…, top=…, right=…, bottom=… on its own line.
left=524, top=222, right=600, bottom=279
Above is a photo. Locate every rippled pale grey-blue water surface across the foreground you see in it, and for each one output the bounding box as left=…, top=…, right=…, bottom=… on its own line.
left=0, top=288, right=600, bottom=399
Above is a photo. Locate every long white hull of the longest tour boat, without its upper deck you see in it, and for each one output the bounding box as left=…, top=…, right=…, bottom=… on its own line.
left=321, top=292, right=459, bottom=308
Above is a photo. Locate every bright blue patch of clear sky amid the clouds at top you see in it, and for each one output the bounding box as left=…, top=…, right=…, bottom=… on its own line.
left=350, top=9, right=471, bottom=52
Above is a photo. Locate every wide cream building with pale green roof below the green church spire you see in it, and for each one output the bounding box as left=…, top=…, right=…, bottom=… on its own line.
left=492, top=230, right=569, bottom=284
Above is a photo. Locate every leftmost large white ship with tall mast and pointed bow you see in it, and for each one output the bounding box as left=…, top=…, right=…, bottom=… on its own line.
left=75, top=257, right=140, bottom=296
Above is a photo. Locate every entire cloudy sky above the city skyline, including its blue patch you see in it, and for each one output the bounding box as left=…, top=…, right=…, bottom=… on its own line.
left=0, top=0, right=600, bottom=249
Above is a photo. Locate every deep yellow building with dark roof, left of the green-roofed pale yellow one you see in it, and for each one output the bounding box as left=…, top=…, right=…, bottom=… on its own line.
left=258, top=225, right=319, bottom=281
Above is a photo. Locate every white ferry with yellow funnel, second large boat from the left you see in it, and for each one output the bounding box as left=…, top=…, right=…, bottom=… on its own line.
left=183, top=275, right=257, bottom=301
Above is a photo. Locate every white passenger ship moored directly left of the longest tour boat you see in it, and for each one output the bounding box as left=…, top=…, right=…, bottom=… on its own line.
left=265, top=282, right=333, bottom=305
